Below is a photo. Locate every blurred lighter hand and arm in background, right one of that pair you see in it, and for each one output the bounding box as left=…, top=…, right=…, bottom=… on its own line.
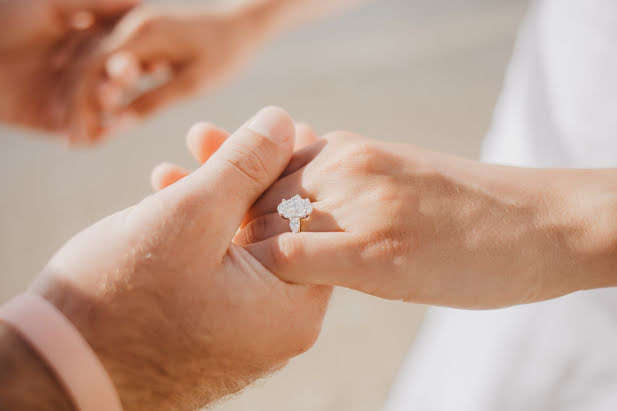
left=100, top=0, right=362, bottom=138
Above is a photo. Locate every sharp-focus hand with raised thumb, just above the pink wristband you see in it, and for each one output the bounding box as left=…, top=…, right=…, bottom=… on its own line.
left=24, top=108, right=331, bottom=410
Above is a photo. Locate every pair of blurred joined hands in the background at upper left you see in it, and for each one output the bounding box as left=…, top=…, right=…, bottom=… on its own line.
left=0, top=0, right=362, bottom=144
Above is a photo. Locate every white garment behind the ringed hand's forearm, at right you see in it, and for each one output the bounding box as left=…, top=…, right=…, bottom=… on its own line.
left=386, top=0, right=617, bottom=411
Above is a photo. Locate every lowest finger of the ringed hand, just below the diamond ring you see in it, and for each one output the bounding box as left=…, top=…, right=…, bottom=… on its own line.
left=244, top=232, right=358, bottom=286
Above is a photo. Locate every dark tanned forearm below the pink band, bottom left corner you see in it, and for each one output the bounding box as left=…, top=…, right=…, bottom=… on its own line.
left=0, top=323, right=73, bottom=411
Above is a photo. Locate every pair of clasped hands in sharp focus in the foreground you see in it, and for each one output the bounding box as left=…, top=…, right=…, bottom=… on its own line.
left=33, top=107, right=606, bottom=409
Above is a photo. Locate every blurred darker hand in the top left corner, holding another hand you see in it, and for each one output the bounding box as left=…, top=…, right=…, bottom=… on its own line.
left=0, top=0, right=139, bottom=142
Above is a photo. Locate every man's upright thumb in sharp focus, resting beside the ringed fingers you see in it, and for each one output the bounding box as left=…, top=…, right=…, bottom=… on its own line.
left=187, top=107, right=295, bottom=241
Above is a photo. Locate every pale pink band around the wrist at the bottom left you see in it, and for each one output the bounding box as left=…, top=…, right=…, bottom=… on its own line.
left=0, top=294, right=122, bottom=411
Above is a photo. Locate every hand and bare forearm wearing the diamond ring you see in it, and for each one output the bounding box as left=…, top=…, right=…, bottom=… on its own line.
left=153, top=128, right=617, bottom=309
